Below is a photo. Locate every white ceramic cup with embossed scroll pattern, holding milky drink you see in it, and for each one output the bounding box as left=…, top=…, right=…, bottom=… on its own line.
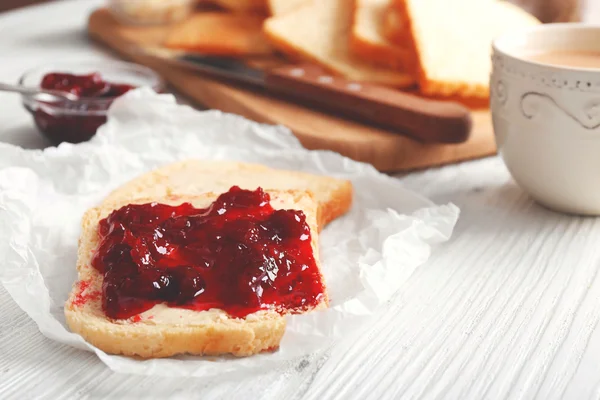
left=490, top=24, right=600, bottom=215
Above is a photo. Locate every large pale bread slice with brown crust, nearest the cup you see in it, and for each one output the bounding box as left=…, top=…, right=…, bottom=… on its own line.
left=393, top=0, right=540, bottom=99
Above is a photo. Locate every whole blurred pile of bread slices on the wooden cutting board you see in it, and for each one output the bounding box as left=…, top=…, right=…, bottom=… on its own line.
left=155, top=0, right=580, bottom=105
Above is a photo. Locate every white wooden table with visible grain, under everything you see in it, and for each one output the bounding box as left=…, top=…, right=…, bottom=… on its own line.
left=0, top=0, right=600, bottom=399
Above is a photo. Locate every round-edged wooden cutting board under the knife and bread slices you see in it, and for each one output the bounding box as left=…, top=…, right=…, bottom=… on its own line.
left=88, top=9, right=496, bottom=172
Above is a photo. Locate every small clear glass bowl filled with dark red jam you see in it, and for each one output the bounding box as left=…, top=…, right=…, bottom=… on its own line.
left=19, top=61, right=163, bottom=144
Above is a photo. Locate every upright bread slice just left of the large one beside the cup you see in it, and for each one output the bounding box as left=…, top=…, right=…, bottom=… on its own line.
left=350, top=0, right=415, bottom=71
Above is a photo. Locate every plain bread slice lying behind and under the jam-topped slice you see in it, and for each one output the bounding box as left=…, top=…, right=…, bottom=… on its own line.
left=104, top=160, right=352, bottom=228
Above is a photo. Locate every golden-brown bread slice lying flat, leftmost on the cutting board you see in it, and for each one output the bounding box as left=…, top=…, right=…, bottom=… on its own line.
left=164, top=12, right=272, bottom=57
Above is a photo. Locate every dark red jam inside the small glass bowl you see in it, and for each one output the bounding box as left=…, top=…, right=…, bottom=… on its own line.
left=31, top=73, right=134, bottom=143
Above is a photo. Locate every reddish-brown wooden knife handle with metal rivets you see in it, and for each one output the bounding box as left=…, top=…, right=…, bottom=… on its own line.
left=265, top=65, right=472, bottom=143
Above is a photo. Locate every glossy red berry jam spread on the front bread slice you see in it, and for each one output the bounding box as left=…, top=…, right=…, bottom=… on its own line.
left=92, top=186, right=324, bottom=319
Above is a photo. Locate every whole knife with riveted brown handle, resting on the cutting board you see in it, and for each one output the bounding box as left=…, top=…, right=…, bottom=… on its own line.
left=139, top=47, right=472, bottom=143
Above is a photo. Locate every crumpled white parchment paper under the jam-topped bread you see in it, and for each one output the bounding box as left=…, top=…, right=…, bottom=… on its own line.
left=0, top=89, right=459, bottom=377
